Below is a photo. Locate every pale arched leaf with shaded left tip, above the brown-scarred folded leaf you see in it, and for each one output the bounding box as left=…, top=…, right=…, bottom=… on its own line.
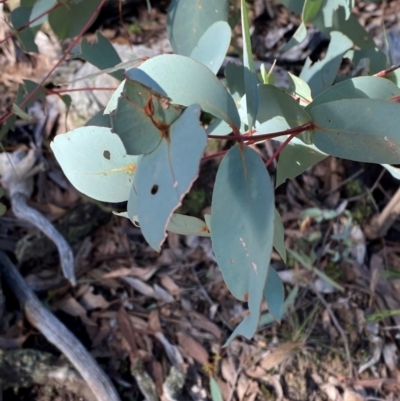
left=126, top=54, right=240, bottom=127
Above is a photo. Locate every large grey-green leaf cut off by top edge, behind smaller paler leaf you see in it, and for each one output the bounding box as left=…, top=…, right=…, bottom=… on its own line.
left=167, top=0, right=229, bottom=56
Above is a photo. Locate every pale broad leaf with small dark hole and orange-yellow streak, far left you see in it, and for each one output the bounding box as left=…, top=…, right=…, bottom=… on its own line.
left=50, top=127, right=137, bottom=202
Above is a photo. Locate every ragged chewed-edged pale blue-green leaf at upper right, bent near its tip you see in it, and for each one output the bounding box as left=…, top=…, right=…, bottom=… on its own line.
left=300, top=32, right=353, bottom=97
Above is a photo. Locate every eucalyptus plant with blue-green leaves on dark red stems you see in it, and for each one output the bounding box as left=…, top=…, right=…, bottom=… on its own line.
left=3, top=0, right=400, bottom=342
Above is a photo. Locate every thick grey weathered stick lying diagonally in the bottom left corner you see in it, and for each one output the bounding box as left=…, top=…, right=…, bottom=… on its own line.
left=0, top=251, right=120, bottom=401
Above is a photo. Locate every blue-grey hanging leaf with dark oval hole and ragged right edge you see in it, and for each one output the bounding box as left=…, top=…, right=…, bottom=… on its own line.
left=134, top=105, right=207, bottom=251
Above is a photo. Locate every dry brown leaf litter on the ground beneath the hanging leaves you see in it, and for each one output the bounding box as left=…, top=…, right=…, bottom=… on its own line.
left=0, top=2, right=400, bottom=401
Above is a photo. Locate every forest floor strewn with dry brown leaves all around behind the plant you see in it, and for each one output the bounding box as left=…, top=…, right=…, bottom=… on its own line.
left=0, top=0, right=400, bottom=401
